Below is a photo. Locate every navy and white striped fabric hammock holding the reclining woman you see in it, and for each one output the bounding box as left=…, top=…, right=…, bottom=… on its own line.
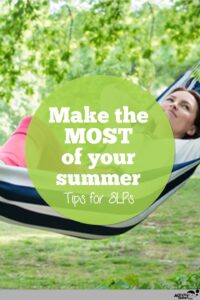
left=0, top=62, right=200, bottom=239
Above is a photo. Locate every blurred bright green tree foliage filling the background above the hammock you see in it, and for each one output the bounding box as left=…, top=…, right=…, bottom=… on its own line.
left=0, top=0, right=200, bottom=143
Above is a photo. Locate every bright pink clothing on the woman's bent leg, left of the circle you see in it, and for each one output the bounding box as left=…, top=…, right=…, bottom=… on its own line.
left=0, top=117, right=32, bottom=168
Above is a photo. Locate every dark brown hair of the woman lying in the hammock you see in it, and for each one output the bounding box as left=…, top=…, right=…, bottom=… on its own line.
left=170, top=87, right=200, bottom=139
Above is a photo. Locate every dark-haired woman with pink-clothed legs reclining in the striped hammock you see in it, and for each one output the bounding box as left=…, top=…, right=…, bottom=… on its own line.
left=0, top=87, right=200, bottom=168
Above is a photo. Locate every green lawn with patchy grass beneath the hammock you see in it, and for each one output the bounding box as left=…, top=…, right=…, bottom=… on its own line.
left=0, top=179, right=200, bottom=289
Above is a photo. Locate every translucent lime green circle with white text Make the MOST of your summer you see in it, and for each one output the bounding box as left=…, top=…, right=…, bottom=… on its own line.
left=26, top=76, right=174, bottom=225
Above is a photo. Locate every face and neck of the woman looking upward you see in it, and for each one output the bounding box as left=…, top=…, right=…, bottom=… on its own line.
left=161, top=91, right=198, bottom=139
